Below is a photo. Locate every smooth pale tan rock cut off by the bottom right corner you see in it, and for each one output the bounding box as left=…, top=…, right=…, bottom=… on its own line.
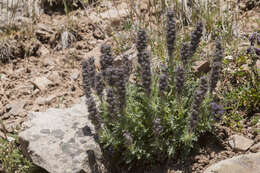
left=204, top=152, right=260, bottom=173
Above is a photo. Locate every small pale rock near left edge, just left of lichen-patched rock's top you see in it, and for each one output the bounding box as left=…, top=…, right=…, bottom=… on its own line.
left=5, top=101, right=26, bottom=116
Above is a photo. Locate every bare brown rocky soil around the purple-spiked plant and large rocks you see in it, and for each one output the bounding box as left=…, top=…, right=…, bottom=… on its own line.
left=0, top=0, right=260, bottom=173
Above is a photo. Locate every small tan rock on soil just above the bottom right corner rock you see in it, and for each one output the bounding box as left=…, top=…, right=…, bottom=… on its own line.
left=229, top=135, right=254, bottom=151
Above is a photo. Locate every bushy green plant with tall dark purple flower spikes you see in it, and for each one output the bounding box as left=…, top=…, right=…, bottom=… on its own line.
left=82, top=11, right=223, bottom=166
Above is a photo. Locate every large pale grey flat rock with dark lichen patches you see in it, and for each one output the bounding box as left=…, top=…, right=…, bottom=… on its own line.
left=19, top=97, right=104, bottom=173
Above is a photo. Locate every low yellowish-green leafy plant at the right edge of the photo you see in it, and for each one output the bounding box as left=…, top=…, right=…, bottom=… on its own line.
left=221, top=33, right=260, bottom=119
